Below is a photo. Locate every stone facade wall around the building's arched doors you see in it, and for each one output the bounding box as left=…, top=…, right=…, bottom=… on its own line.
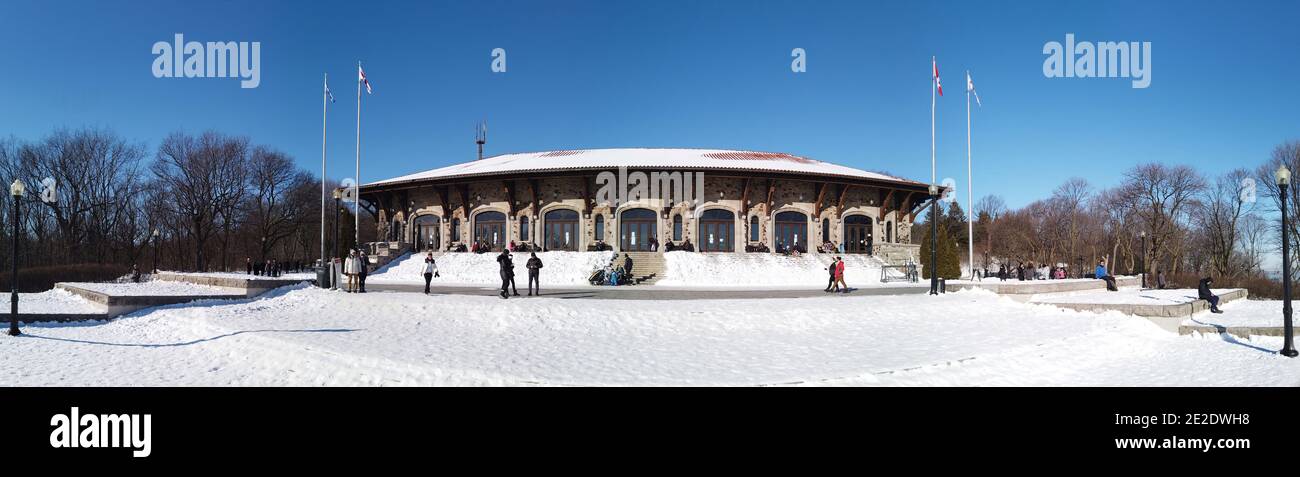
left=380, top=175, right=911, bottom=256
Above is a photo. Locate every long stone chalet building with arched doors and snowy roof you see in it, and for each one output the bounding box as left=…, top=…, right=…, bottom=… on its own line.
left=360, top=148, right=930, bottom=261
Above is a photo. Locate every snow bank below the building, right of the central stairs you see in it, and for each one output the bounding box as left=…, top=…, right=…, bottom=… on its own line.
left=655, top=252, right=901, bottom=289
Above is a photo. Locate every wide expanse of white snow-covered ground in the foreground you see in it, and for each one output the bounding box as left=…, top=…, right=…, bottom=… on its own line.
left=0, top=286, right=1300, bottom=386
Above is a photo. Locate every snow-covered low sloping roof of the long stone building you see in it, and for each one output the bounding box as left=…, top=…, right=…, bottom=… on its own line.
left=364, top=148, right=924, bottom=187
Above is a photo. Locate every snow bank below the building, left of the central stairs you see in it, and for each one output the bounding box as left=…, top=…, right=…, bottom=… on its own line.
left=367, top=252, right=614, bottom=286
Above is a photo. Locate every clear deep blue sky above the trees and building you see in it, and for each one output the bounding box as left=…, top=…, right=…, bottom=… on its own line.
left=0, top=1, right=1300, bottom=207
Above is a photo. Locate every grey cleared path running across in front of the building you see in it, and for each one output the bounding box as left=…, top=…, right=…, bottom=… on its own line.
left=365, top=283, right=930, bottom=300
